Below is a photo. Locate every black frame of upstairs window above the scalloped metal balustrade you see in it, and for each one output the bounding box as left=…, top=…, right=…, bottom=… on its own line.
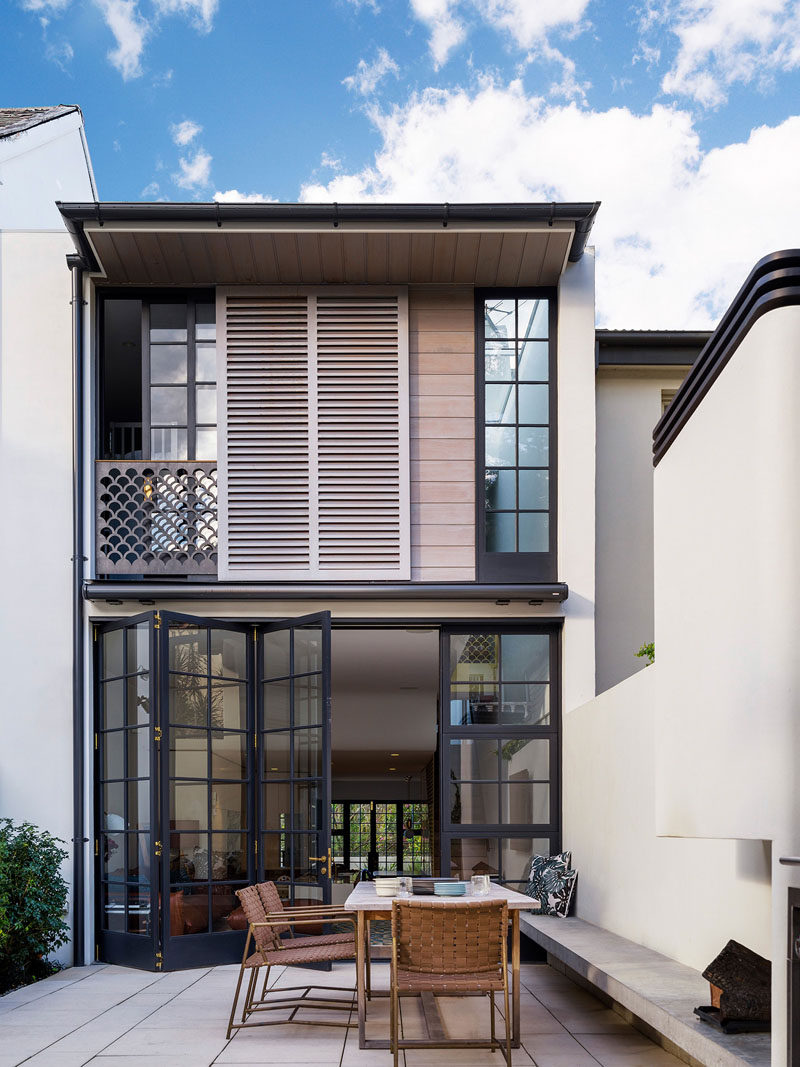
left=94, top=286, right=220, bottom=463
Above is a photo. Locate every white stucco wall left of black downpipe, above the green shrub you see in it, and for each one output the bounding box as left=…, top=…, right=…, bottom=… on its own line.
left=0, top=233, right=73, bottom=957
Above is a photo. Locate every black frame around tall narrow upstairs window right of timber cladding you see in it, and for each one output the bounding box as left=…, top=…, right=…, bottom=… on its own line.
left=475, top=286, right=558, bottom=583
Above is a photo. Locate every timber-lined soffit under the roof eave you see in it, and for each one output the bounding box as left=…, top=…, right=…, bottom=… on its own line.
left=85, top=223, right=573, bottom=286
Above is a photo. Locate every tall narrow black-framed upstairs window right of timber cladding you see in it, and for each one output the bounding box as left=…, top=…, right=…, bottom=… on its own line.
left=477, top=290, right=556, bottom=582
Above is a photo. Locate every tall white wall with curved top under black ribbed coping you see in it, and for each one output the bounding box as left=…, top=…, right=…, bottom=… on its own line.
left=655, top=307, right=800, bottom=1067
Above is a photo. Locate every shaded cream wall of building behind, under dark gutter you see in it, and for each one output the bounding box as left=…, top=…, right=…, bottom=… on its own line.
left=595, top=367, right=687, bottom=692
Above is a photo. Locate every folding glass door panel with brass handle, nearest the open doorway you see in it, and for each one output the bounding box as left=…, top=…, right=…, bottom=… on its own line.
left=257, top=611, right=333, bottom=905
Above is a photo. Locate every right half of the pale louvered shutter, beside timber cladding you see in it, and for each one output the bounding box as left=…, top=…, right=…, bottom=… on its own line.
left=317, top=296, right=407, bottom=577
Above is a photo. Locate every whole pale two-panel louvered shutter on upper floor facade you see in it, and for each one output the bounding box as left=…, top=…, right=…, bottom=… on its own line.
left=218, top=288, right=411, bottom=582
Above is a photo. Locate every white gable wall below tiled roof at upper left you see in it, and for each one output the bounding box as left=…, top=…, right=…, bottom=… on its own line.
left=0, top=111, right=97, bottom=229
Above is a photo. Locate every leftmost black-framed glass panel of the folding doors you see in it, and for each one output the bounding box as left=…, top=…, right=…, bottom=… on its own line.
left=95, top=615, right=158, bottom=970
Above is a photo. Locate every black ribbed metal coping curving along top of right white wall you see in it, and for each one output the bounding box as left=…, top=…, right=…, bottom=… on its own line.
left=653, top=249, right=800, bottom=466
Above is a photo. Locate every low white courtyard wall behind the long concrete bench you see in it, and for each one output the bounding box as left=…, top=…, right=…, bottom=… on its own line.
left=563, top=664, right=771, bottom=970
